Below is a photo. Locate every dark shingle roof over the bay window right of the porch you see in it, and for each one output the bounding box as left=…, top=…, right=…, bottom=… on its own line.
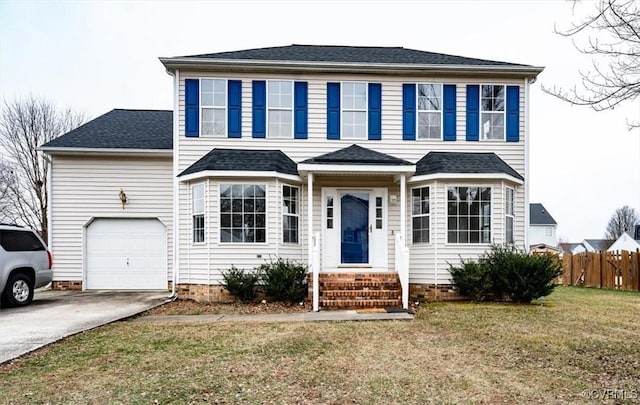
left=415, top=152, right=524, bottom=180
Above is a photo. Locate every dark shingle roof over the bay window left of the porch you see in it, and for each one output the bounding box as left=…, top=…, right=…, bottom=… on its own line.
left=178, top=148, right=298, bottom=177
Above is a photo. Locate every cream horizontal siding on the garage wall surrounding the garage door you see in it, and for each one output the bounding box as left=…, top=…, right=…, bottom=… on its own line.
left=50, top=156, right=172, bottom=282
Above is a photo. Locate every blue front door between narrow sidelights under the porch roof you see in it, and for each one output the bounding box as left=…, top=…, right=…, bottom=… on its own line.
left=340, top=193, right=369, bottom=263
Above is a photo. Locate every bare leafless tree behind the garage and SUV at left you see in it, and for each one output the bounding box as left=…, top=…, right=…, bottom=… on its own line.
left=0, top=96, right=86, bottom=240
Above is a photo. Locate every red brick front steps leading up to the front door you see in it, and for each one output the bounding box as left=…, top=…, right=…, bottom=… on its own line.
left=309, top=273, right=402, bottom=309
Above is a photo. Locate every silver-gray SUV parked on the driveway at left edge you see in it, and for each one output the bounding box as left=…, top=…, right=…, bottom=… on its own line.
left=0, top=224, right=53, bottom=307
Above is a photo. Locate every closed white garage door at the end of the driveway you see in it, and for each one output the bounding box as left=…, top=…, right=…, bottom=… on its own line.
left=86, top=218, right=167, bottom=290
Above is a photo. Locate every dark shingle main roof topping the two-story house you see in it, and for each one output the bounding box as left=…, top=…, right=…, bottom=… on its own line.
left=184, top=44, right=527, bottom=67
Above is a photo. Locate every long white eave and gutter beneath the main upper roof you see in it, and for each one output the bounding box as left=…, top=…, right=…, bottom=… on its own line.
left=159, top=57, right=544, bottom=78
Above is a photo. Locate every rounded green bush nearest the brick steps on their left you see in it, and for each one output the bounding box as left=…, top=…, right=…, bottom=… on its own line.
left=258, top=258, right=307, bottom=303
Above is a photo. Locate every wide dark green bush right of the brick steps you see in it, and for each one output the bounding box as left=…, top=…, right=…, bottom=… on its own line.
left=450, top=245, right=562, bottom=303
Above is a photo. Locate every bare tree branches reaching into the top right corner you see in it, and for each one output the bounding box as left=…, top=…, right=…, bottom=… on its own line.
left=542, top=0, right=640, bottom=129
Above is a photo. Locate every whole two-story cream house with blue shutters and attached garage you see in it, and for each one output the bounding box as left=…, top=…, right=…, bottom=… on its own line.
left=42, top=45, right=542, bottom=310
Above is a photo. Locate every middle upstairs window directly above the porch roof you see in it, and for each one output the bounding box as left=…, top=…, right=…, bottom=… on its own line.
left=342, top=82, right=367, bottom=139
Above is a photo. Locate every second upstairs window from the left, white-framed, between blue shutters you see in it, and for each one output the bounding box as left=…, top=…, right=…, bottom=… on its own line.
left=267, top=80, right=293, bottom=138
